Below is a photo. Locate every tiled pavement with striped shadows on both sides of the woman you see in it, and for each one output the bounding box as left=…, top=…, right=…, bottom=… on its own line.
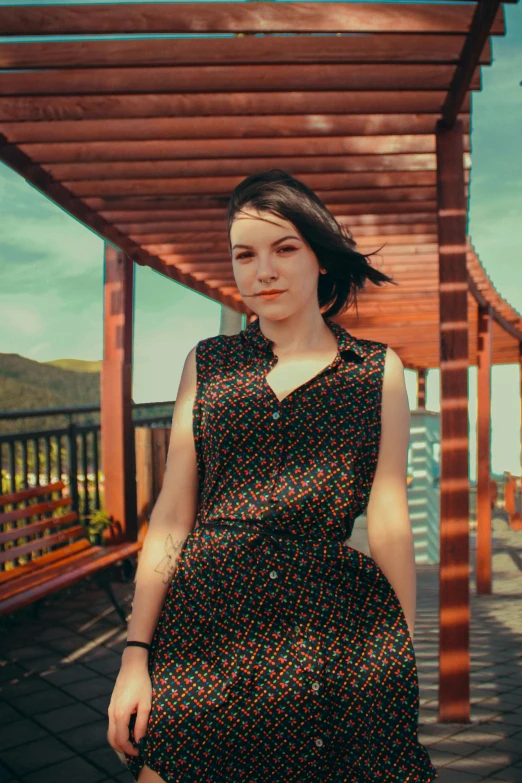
left=0, top=522, right=522, bottom=783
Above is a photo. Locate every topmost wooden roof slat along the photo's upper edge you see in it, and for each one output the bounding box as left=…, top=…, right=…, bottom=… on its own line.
left=0, top=2, right=503, bottom=37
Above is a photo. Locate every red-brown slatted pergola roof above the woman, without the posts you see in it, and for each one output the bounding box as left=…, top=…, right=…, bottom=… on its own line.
left=0, top=0, right=522, bottom=367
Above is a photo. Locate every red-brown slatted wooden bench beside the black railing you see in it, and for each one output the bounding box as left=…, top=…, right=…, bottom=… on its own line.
left=0, top=481, right=142, bottom=623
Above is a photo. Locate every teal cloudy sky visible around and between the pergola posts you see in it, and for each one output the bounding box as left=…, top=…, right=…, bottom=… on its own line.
left=0, top=2, right=522, bottom=479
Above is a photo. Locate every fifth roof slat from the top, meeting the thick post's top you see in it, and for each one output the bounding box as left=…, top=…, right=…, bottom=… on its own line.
left=0, top=113, right=470, bottom=144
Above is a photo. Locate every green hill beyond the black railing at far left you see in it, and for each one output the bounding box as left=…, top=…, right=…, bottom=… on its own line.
left=0, top=353, right=101, bottom=434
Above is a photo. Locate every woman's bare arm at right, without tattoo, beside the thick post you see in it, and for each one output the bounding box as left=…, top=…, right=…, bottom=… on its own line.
left=366, top=346, right=417, bottom=639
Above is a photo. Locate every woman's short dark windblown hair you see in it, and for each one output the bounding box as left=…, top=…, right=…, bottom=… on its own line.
left=227, top=169, right=397, bottom=316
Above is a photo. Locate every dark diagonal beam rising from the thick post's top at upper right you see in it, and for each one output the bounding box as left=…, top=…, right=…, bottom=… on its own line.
left=442, top=0, right=504, bottom=128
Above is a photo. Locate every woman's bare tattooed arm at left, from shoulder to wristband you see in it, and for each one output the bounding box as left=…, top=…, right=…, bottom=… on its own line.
left=122, top=348, right=199, bottom=666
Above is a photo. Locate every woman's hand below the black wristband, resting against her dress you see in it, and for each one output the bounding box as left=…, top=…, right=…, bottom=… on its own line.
left=107, top=649, right=152, bottom=756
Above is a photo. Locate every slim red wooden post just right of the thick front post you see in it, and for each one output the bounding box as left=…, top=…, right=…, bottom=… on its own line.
left=476, top=305, right=492, bottom=593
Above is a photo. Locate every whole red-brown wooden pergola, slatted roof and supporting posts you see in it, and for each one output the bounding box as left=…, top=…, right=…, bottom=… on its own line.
left=0, top=0, right=522, bottom=722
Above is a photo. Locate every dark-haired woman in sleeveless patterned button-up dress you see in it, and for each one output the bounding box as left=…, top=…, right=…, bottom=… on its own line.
left=108, top=169, right=438, bottom=783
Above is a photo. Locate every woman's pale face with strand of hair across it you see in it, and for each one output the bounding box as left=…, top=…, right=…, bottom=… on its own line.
left=230, top=209, right=320, bottom=320
